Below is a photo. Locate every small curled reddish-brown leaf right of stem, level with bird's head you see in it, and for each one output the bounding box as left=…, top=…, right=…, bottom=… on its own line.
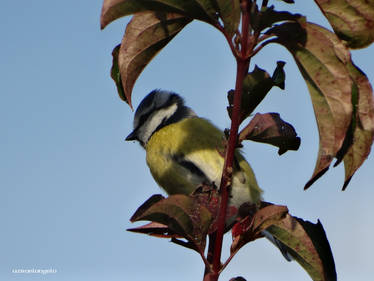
left=238, top=113, right=300, bottom=155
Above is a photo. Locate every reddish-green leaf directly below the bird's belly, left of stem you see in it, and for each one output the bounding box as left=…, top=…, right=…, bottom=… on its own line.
left=131, top=194, right=213, bottom=246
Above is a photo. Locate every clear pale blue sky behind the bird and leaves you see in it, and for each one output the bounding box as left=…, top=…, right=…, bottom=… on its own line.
left=0, top=0, right=374, bottom=281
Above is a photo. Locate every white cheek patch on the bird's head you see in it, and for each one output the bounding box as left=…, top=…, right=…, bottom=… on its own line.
left=138, top=103, right=178, bottom=144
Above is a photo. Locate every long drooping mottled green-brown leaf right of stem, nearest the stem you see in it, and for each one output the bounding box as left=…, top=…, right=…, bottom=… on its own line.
left=268, top=23, right=353, bottom=188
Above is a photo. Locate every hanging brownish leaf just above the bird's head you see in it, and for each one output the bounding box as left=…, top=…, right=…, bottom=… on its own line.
left=116, top=12, right=191, bottom=107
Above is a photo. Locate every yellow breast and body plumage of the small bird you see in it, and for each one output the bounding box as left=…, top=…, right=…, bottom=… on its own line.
left=146, top=117, right=261, bottom=205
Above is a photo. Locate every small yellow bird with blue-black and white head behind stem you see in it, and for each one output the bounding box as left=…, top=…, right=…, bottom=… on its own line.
left=126, top=89, right=292, bottom=261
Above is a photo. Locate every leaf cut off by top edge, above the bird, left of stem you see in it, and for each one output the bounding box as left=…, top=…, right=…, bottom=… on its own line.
left=100, top=0, right=217, bottom=29
